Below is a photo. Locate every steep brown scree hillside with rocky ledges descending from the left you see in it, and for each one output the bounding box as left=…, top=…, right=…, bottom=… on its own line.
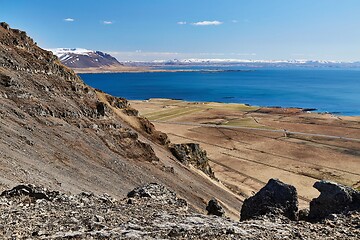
left=0, top=23, right=241, bottom=217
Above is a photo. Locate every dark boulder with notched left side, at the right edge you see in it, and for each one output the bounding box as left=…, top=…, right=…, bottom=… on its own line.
left=309, top=181, right=360, bottom=220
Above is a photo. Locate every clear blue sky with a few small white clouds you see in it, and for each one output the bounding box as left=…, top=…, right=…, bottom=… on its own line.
left=0, top=0, right=360, bottom=61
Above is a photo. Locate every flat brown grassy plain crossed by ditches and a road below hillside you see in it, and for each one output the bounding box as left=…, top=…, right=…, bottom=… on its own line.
left=131, top=99, right=360, bottom=207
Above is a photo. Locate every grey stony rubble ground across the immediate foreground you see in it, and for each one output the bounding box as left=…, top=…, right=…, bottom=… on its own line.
left=0, top=180, right=360, bottom=239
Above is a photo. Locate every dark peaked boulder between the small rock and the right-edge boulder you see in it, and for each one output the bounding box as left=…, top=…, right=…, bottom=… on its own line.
left=240, top=179, right=298, bottom=221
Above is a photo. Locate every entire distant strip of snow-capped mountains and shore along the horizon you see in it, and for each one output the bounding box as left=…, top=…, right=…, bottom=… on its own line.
left=48, top=48, right=360, bottom=72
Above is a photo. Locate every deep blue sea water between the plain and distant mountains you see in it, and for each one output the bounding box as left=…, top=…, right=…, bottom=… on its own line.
left=80, top=69, right=360, bottom=116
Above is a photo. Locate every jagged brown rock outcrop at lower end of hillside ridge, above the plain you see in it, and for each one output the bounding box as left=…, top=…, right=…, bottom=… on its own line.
left=170, top=143, right=215, bottom=178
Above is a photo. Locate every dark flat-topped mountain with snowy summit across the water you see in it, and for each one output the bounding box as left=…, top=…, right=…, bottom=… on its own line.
left=48, top=48, right=122, bottom=68
